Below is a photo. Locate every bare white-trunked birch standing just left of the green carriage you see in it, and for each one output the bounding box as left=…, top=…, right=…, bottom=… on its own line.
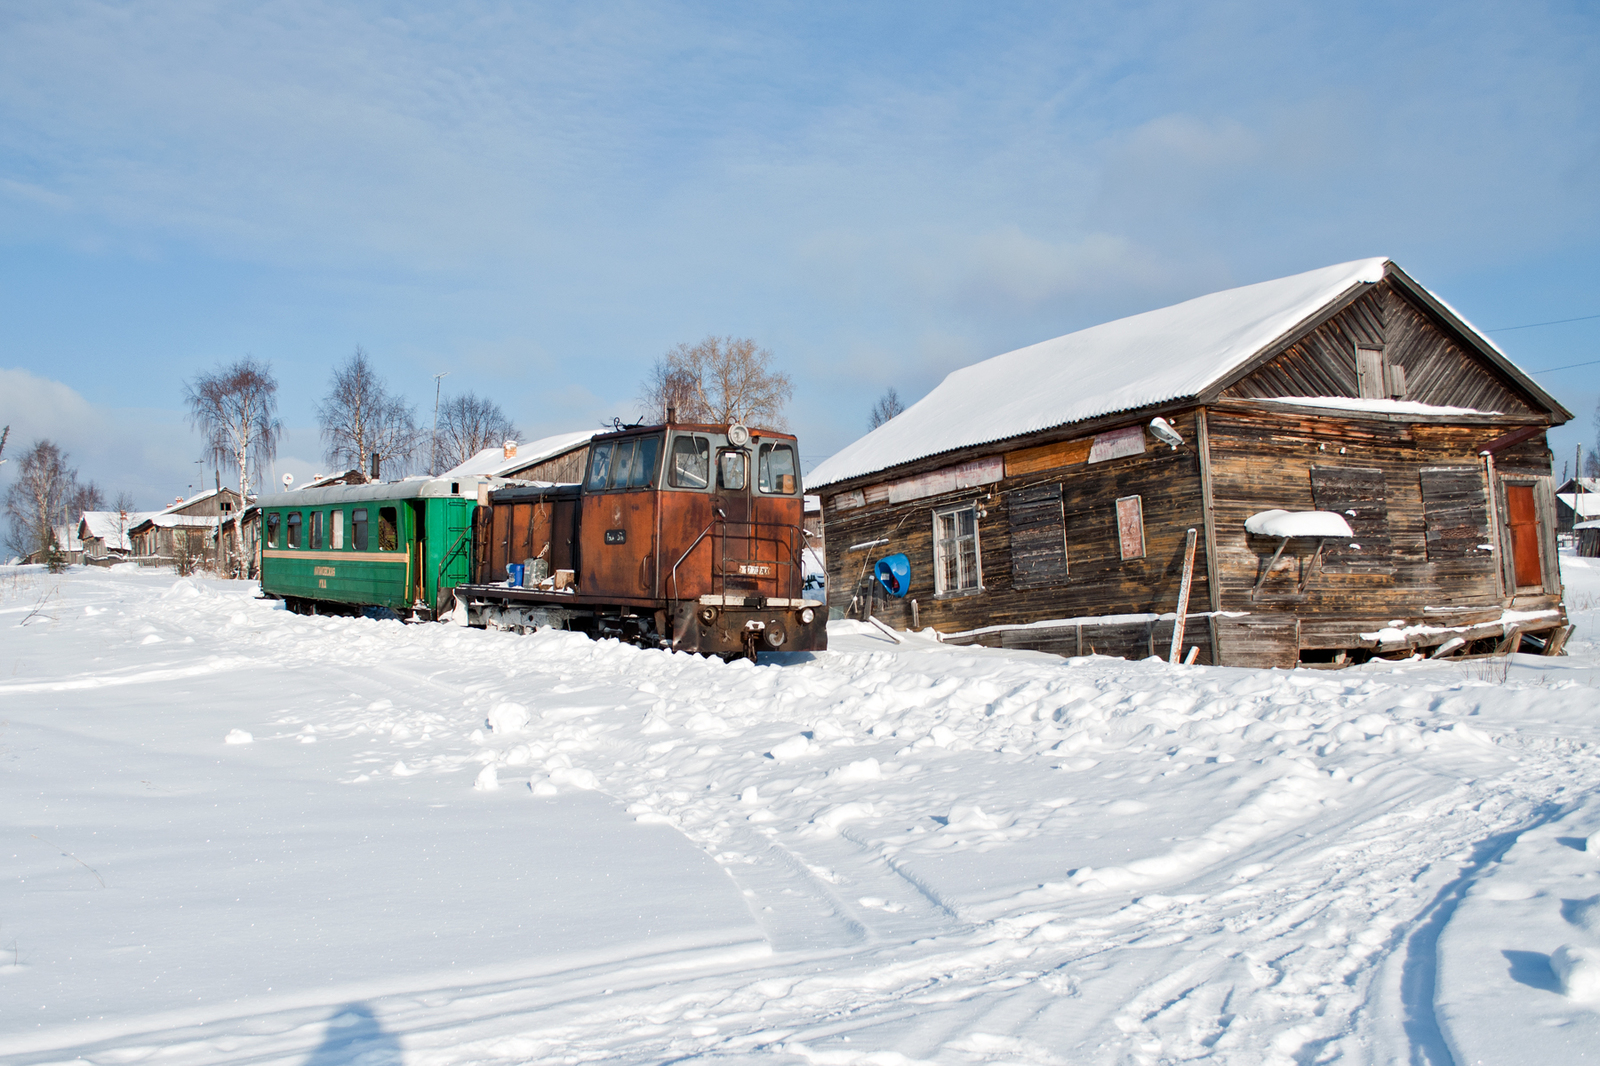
left=184, top=355, right=283, bottom=501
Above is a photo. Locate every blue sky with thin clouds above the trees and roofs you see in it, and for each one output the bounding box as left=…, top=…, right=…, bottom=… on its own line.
left=0, top=0, right=1600, bottom=506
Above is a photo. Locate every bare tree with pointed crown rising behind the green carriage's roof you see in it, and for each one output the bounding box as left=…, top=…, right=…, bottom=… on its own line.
left=317, top=346, right=426, bottom=474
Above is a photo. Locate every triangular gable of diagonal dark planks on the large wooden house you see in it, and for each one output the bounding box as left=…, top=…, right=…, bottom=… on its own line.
left=1218, top=277, right=1555, bottom=418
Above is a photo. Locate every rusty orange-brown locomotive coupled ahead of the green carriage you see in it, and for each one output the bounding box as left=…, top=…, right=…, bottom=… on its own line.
left=454, top=421, right=827, bottom=659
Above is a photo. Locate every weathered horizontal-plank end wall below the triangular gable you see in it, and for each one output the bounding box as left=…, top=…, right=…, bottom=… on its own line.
left=1206, top=403, right=1558, bottom=648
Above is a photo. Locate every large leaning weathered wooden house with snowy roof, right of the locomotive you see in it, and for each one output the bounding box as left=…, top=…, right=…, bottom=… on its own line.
left=808, top=259, right=1571, bottom=666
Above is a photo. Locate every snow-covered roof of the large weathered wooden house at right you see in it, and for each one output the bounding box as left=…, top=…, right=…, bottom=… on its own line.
left=806, top=258, right=1554, bottom=490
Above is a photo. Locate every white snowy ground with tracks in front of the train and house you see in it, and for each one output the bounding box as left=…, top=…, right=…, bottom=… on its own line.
left=0, top=559, right=1600, bottom=1066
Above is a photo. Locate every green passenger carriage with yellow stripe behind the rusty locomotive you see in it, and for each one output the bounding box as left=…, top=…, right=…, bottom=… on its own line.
left=258, top=477, right=482, bottom=618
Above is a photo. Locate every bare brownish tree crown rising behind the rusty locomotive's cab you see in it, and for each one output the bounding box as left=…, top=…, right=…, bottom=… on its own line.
left=640, top=336, right=794, bottom=429
